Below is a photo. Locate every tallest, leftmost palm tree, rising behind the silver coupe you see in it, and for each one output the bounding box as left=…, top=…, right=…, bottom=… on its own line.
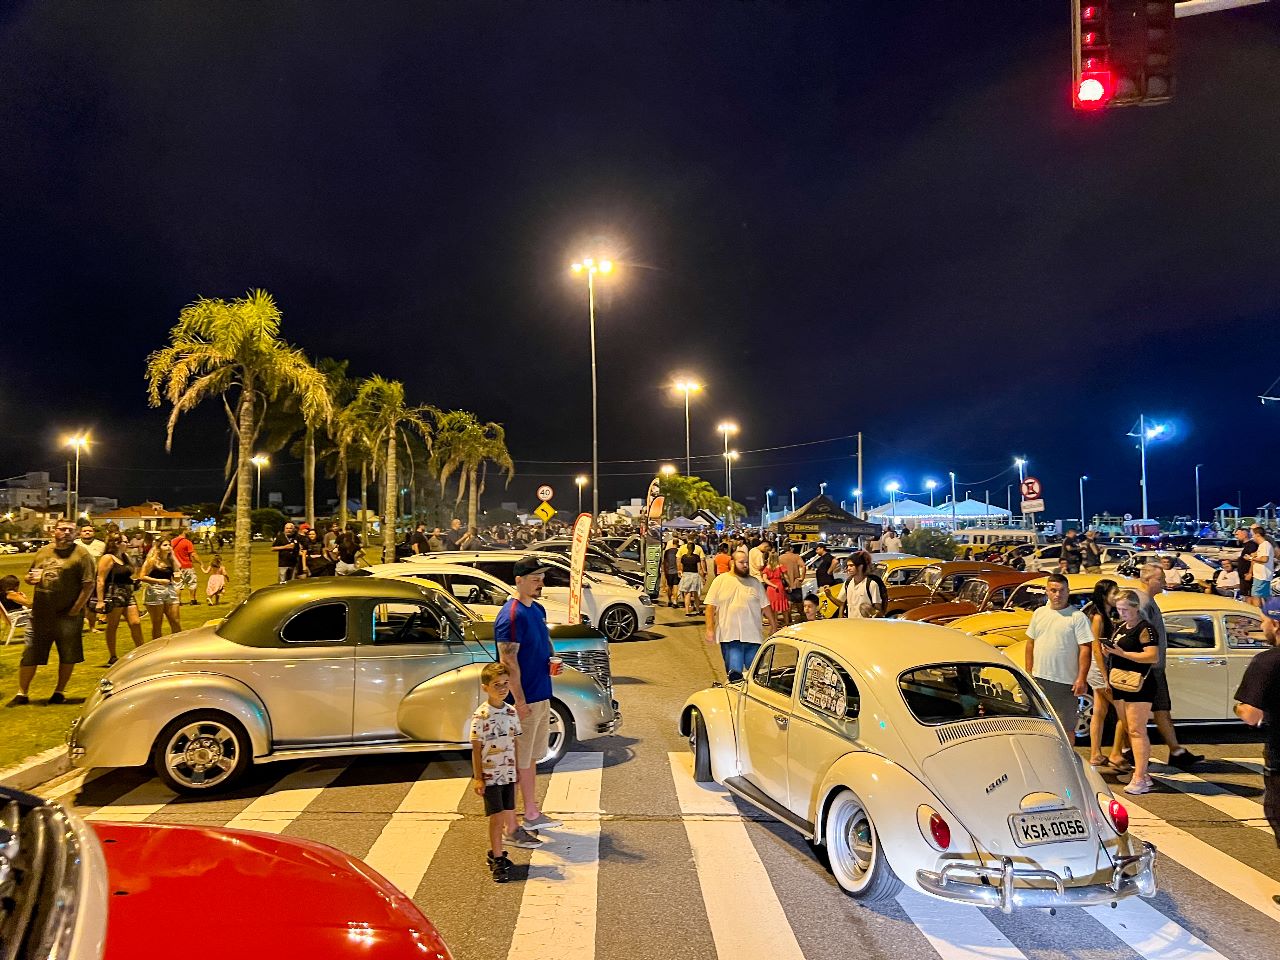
left=146, top=291, right=332, bottom=599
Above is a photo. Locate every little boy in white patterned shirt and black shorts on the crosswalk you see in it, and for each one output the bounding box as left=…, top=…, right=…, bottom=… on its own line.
left=471, top=663, right=541, bottom=883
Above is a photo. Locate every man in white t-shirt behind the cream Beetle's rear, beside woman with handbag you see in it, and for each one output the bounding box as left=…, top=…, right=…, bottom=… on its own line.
left=1027, top=573, right=1093, bottom=736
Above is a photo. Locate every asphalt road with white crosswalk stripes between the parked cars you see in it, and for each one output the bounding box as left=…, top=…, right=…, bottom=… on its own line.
left=35, top=608, right=1280, bottom=960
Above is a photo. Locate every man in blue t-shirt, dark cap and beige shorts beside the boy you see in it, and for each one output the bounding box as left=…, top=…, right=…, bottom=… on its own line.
left=493, top=557, right=563, bottom=838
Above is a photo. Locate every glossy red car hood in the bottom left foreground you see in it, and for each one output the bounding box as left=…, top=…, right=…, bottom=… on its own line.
left=92, top=823, right=449, bottom=960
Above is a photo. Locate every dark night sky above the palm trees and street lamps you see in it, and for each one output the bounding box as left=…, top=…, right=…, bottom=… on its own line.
left=0, top=0, right=1280, bottom=527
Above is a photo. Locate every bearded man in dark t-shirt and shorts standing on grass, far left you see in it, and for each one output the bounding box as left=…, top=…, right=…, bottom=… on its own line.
left=9, top=520, right=97, bottom=707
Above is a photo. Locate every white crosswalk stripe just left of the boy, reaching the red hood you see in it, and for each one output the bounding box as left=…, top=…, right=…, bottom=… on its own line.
left=365, top=760, right=471, bottom=897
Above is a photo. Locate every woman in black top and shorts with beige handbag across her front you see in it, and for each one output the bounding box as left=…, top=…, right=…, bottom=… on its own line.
left=1103, top=590, right=1160, bottom=795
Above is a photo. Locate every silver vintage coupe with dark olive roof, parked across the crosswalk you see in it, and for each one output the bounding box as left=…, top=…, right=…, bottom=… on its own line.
left=68, top=577, right=622, bottom=794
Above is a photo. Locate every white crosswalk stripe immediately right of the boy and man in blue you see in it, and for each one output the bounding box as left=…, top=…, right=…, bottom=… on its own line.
left=507, top=753, right=604, bottom=960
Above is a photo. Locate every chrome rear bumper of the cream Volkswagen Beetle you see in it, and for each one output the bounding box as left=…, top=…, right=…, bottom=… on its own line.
left=915, top=841, right=1156, bottom=914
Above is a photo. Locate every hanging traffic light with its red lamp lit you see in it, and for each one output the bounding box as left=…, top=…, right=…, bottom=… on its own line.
left=1071, top=0, right=1175, bottom=110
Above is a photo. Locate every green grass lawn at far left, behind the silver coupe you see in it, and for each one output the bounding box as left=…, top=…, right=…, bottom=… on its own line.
left=0, top=544, right=371, bottom=768
